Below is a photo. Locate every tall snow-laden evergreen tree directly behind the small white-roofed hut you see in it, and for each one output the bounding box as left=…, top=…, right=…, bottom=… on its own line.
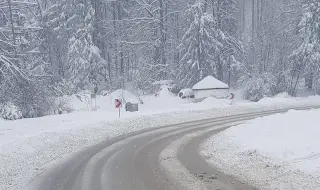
left=177, top=1, right=223, bottom=86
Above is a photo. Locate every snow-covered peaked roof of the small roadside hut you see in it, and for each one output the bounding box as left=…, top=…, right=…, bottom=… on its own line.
left=192, top=76, right=229, bottom=90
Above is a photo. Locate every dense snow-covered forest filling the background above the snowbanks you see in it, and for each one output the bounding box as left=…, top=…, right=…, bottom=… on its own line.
left=0, top=0, right=320, bottom=117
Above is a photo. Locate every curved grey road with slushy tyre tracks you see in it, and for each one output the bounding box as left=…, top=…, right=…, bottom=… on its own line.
left=27, top=107, right=316, bottom=190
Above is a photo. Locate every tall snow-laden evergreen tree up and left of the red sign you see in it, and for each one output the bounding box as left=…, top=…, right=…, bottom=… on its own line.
left=67, top=1, right=105, bottom=89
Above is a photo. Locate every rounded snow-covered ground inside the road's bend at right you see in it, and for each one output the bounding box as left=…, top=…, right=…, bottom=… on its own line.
left=200, top=110, right=320, bottom=190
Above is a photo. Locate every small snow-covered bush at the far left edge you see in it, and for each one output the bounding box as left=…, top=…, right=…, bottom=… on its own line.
left=0, top=102, right=22, bottom=120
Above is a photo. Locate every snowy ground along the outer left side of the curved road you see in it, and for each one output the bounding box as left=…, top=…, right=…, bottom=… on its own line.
left=0, top=92, right=320, bottom=190
